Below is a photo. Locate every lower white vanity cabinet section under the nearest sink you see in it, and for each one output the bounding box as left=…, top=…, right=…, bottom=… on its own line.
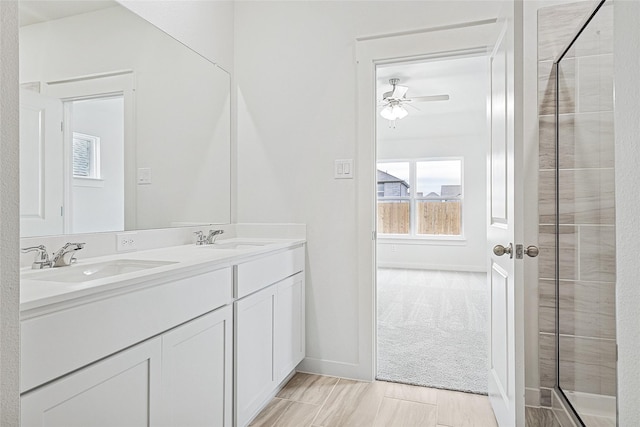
left=21, top=267, right=233, bottom=427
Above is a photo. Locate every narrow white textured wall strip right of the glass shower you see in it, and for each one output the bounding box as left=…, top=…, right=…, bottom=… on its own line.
left=613, top=0, right=640, bottom=426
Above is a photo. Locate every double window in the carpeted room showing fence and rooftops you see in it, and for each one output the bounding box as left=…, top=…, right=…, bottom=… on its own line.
left=377, top=159, right=462, bottom=237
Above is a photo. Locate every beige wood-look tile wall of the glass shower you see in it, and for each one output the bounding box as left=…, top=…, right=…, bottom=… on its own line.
left=538, top=1, right=616, bottom=412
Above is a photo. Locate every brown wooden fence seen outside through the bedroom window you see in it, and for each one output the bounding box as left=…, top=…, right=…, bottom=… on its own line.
left=378, top=201, right=462, bottom=236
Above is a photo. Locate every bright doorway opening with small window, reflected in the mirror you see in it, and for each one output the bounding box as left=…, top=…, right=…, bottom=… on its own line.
left=65, top=95, right=124, bottom=233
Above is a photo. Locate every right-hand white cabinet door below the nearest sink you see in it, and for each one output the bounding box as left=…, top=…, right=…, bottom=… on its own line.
left=162, top=305, right=233, bottom=427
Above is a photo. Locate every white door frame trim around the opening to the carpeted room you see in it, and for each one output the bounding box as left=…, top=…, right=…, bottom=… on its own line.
left=356, top=20, right=500, bottom=381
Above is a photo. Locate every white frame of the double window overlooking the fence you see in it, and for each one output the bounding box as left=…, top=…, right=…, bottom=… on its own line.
left=376, top=156, right=466, bottom=244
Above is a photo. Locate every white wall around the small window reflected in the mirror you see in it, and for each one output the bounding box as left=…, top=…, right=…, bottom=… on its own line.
left=71, top=97, right=124, bottom=233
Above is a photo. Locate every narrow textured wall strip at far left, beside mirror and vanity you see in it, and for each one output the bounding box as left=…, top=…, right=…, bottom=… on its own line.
left=0, top=1, right=20, bottom=426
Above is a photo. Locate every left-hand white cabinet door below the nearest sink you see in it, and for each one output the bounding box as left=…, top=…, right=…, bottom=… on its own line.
left=21, top=338, right=161, bottom=427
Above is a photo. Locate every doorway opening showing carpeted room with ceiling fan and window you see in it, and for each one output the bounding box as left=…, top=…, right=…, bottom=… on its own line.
left=376, top=55, right=490, bottom=394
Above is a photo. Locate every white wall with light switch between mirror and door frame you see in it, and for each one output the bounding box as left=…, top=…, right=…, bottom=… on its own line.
left=235, top=1, right=499, bottom=377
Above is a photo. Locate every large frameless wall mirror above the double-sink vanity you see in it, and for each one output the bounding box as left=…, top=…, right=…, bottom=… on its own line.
left=20, top=1, right=231, bottom=237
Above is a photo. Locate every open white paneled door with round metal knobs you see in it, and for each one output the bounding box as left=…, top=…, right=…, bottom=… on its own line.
left=487, top=10, right=524, bottom=427
